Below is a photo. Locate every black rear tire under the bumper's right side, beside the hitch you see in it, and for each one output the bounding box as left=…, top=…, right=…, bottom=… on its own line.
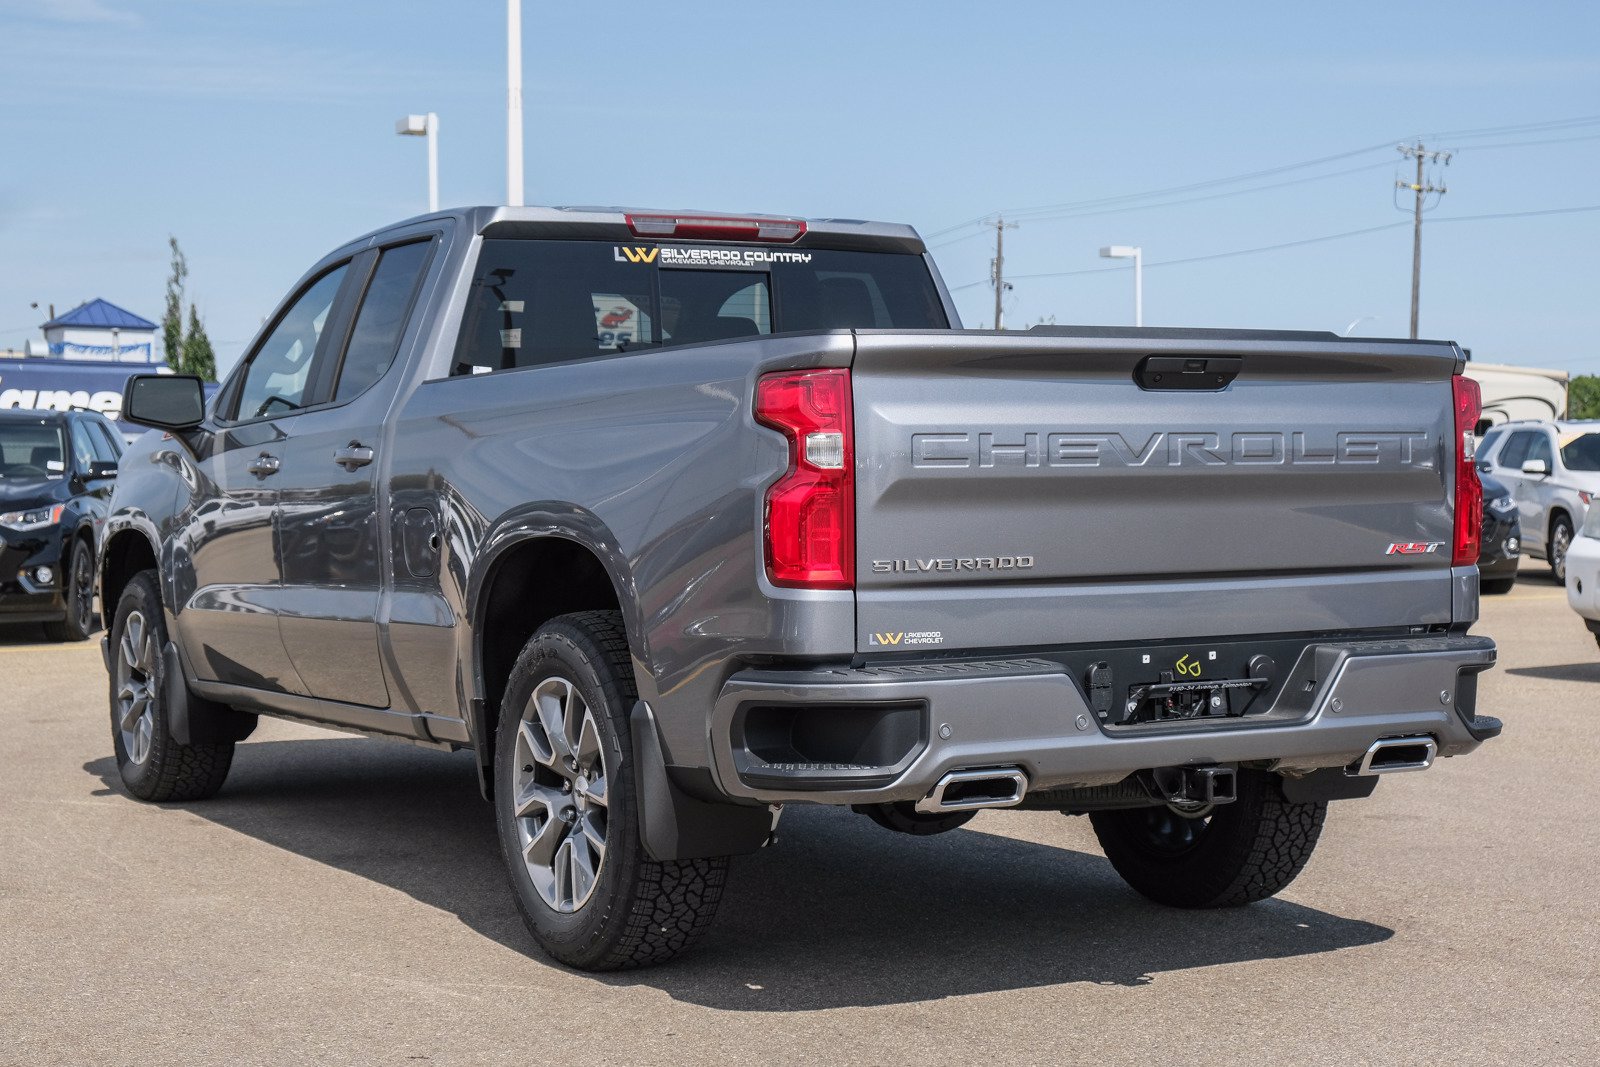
left=1090, top=771, right=1328, bottom=907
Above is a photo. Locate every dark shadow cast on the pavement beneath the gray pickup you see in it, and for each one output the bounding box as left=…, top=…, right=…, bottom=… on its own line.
left=85, top=739, right=1394, bottom=1011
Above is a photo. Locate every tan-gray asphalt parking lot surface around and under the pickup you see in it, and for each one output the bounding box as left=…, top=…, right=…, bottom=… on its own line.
left=0, top=563, right=1600, bottom=1065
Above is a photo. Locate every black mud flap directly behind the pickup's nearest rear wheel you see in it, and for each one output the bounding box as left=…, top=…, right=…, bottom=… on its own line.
left=629, top=701, right=773, bottom=862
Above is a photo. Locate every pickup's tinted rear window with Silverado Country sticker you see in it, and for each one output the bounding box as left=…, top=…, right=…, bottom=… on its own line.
left=454, top=238, right=950, bottom=374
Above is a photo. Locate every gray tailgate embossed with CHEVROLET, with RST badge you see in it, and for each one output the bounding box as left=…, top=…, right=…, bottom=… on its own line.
left=851, top=330, right=1459, bottom=651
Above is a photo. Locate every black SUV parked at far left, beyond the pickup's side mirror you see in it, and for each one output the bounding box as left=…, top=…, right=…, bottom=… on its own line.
left=0, top=410, right=122, bottom=641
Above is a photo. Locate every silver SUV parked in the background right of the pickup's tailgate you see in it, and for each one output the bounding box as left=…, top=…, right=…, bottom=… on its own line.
left=1478, top=421, right=1600, bottom=582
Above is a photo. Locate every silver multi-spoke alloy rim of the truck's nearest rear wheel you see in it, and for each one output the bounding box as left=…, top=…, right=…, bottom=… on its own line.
left=510, top=675, right=608, bottom=912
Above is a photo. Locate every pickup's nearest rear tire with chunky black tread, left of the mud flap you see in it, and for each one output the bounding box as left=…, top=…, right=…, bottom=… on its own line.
left=494, top=611, right=728, bottom=971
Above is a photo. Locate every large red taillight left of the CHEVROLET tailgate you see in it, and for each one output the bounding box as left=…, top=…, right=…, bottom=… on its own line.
left=755, top=370, right=856, bottom=589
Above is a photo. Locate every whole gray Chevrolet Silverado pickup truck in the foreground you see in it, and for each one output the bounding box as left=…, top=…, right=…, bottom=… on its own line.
left=99, top=208, right=1501, bottom=969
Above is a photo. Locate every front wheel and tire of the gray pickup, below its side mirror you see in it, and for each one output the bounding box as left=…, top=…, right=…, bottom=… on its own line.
left=110, top=569, right=234, bottom=803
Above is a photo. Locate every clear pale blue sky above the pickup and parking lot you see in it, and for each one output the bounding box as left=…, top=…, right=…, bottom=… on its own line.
left=0, top=0, right=1600, bottom=373
